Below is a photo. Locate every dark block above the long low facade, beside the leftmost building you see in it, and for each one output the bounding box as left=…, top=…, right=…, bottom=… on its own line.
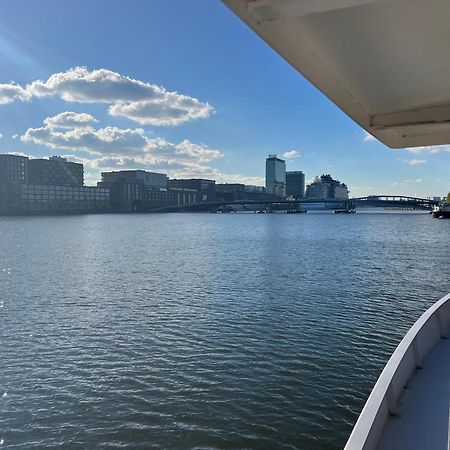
left=28, top=156, right=84, bottom=186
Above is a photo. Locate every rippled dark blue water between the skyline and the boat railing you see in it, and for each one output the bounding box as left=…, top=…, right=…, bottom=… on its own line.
left=0, top=213, right=450, bottom=450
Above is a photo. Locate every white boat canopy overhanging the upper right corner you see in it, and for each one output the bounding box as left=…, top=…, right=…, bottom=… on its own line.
left=223, top=0, right=450, bottom=148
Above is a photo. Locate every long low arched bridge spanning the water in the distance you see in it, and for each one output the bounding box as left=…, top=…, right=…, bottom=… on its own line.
left=148, top=195, right=439, bottom=212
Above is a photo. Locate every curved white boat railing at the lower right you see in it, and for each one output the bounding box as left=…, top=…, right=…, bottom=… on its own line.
left=344, top=294, right=450, bottom=450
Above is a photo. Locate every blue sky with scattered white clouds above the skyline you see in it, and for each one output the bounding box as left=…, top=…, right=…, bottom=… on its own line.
left=0, top=0, right=450, bottom=197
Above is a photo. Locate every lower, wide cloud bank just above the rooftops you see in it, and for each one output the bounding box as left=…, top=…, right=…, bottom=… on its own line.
left=20, top=111, right=263, bottom=184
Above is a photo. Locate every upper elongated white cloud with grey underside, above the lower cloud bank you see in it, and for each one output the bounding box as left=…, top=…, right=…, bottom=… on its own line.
left=27, top=67, right=213, bottom=126
